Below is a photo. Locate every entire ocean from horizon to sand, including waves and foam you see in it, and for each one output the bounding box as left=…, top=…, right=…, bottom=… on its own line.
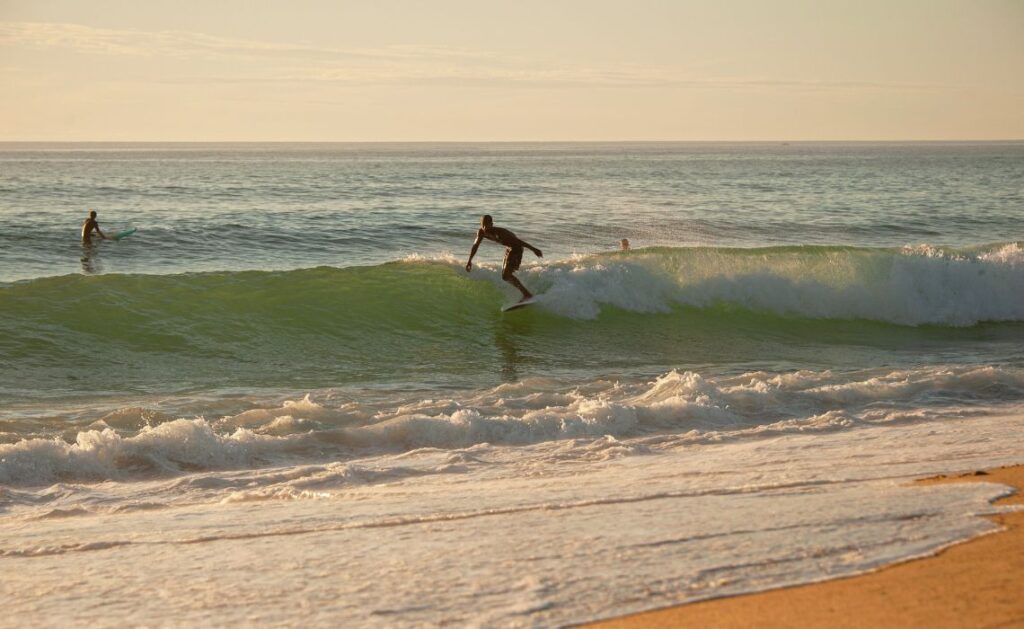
left=0, top=142, right=1024, bottom=626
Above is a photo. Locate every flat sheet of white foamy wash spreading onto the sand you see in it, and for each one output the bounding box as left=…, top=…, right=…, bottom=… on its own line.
left=0, top=411, right=1024, bottom=626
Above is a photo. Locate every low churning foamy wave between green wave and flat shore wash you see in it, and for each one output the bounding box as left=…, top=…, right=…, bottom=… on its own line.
left=0, top=367, right=1024, bottom=487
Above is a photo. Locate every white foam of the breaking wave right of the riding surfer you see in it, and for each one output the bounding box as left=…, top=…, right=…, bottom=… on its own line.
left=462, top=243, right=1024, bottom=326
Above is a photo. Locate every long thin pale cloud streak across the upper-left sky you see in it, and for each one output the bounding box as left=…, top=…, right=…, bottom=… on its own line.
left=0, top=22, right=943, bottom=90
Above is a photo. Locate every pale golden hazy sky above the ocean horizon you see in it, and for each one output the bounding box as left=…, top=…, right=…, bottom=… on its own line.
left=0, top=0, right=1024, bottom=141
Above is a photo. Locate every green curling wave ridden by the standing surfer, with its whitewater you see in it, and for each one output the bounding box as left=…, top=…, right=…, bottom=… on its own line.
left=0, top=243, right=1024, bottom=395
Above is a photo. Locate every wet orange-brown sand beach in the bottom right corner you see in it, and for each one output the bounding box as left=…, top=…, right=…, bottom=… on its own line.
left=585, top=464, right=1024, bottom=629
